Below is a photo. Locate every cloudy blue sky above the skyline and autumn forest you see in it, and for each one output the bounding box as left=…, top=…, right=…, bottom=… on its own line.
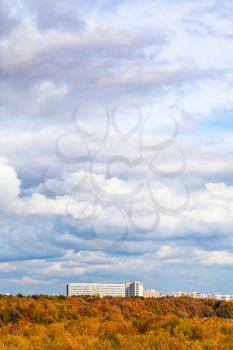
left=0, top=0, right=233, bottom=294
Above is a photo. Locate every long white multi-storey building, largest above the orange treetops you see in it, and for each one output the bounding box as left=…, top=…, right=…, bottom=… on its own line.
left=67, top=281, right=144, bottom=298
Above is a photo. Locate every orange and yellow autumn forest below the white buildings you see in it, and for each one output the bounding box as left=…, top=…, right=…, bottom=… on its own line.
left=0, top=295, right=233, bottom=350
